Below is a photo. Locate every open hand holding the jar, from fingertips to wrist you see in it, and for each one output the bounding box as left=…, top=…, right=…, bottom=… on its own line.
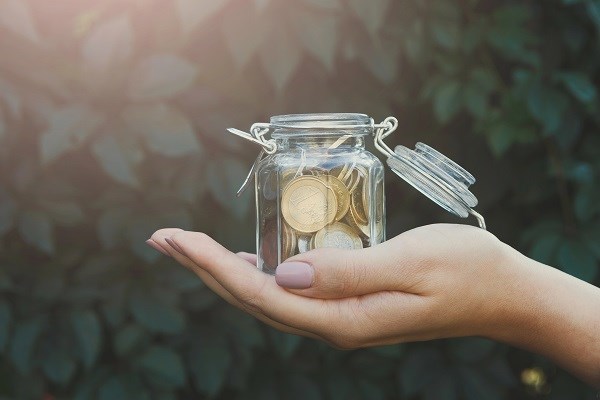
left=151, top=225, right=511, bottom=348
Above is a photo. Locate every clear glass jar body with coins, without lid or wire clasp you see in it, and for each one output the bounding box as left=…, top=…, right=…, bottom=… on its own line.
left=254, top=114, right=385, bottom=274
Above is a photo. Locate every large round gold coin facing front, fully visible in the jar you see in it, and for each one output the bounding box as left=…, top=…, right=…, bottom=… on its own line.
left=281, top=176, right=338, bottom=233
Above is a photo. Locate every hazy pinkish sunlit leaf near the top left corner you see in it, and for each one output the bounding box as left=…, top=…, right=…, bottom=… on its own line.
left=81, top=14, right=133, bottom=72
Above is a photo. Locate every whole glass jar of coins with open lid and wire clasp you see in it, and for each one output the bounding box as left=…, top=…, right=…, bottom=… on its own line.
left=228, top=113, right=485, bottom=274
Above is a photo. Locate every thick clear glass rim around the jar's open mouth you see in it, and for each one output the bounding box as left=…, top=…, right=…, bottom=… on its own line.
left=269, top=113, right=373, bottom=137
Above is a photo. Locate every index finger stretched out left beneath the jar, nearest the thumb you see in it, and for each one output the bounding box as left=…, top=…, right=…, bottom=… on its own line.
left=171, top=232, right=329, bottom=334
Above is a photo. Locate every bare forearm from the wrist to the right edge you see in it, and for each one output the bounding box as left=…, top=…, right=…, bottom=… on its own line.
left=490, top=248, right=600, bottom=387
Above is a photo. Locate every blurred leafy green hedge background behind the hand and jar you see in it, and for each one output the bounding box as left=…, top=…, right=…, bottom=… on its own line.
left=0, top=0, right=600, bottom=400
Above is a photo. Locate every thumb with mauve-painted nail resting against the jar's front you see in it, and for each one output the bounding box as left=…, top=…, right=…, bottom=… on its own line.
left=275, top=237, right=421, bottom=299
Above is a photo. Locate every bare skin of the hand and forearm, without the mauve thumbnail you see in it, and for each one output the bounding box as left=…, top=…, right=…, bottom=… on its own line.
left=148, top=224, right=600, bottom=387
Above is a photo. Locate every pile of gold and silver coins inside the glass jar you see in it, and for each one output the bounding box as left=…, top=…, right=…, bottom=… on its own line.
left=262, top=164, right=383, bottom=266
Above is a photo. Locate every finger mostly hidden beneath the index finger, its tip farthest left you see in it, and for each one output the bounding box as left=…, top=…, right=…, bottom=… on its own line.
left=149, top=228, right=321, bottom=339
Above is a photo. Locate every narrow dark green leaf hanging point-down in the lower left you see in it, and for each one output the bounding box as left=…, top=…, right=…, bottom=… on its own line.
left=71, top=310, right=102, bottom=369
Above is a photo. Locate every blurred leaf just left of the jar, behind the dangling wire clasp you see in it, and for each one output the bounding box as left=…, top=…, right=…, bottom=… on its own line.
left=207, top=158, right=250, bottom=219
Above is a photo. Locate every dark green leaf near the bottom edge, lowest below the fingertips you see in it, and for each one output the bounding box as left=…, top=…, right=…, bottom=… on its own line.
left=136, top=346, right=185, bottom=388
